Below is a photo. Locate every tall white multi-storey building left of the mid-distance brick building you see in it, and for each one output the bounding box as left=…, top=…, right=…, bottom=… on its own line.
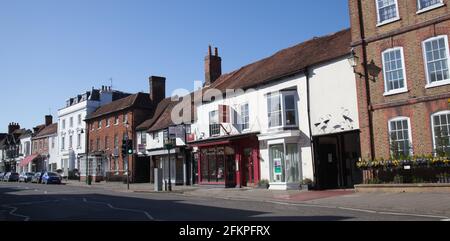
left=56, top=86, right=127, bottom=175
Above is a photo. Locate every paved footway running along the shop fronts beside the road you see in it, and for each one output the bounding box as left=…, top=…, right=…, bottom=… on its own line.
left=62, top=181, right=450, bottom=219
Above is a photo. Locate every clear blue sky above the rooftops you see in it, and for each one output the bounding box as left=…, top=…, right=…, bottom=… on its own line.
left=0, top=0, right=349, bottom=132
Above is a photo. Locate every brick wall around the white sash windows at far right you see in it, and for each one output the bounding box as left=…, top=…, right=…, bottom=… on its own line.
left=349, top=0, right=450, bottom=158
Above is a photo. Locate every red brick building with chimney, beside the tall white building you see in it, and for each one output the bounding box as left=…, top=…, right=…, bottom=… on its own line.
left=84, top=76, right=165, bottom=182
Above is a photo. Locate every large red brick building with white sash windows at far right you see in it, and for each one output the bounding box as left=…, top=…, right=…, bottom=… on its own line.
left=349, top=0, right=450, bottom=163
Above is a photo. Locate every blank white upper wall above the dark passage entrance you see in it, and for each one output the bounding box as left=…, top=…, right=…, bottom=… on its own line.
left=310, top=58, right=359, bottom=136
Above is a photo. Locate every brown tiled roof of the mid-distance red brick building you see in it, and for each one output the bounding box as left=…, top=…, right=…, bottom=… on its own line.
left=86, top=93, right=152, bottom=120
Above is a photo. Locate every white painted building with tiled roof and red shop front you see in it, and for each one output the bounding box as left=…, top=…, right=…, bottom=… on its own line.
left=189, top=30, right=359, bottom=190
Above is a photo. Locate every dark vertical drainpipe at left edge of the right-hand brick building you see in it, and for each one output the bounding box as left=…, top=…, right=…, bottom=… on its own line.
left=357, top=0, right=375, bottom=160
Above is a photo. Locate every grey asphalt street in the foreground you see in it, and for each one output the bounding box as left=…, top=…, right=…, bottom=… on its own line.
left=0, top=183, right=441, bottom=221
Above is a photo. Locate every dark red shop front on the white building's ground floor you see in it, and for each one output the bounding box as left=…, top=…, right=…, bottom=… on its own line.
left=191, top=134, right=260, bottom=188
